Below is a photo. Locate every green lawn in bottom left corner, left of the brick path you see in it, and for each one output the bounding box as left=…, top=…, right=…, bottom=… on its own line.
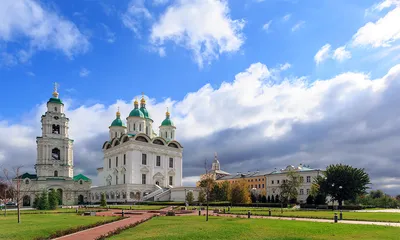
left=0, top=214, right=114, bottom=240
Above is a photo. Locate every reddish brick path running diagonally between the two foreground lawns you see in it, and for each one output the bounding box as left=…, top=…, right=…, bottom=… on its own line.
left=52, top=207, right=172, bottom=240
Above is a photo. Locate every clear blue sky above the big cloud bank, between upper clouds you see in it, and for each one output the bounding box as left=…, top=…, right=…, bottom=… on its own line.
left=0, top=0, right=391, bottom=118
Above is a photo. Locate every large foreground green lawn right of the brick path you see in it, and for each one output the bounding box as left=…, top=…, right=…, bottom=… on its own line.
left=109, top=216, right=400, bottom=240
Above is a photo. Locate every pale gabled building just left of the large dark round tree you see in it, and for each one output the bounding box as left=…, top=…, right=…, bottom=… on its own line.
left=266, top=164, right=322, bottom=203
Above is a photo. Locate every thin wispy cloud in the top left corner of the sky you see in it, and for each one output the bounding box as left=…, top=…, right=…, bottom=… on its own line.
left=0, top=0, right=89, bottom=61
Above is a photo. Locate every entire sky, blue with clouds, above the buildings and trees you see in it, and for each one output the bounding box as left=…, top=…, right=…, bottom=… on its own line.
left=0, top=0, right=400, bottom=194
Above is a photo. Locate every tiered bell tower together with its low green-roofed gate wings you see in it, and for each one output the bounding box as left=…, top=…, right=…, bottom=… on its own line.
left=14, top=87, right=91, bottom=206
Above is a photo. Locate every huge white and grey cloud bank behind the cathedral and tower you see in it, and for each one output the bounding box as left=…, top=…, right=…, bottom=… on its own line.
left=0, top=63, right=400, bottom=193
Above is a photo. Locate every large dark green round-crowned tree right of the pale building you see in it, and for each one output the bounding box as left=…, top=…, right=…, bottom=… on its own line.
left=316, top=164, right=370, bottom=208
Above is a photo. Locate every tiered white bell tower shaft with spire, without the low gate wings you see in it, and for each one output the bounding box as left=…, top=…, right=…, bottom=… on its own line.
left=35, top=83, right=74, bottom=180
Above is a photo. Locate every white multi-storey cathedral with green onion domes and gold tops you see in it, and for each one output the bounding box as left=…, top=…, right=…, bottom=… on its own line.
left=90, top=97, right=183, bottom=202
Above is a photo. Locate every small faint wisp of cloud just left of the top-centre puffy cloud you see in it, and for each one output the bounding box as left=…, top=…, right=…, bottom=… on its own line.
left=121, top=0, right=153, bottom=37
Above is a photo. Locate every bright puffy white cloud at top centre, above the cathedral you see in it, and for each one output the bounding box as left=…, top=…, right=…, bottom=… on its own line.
left=150, top=0, right=245, bottom=67
